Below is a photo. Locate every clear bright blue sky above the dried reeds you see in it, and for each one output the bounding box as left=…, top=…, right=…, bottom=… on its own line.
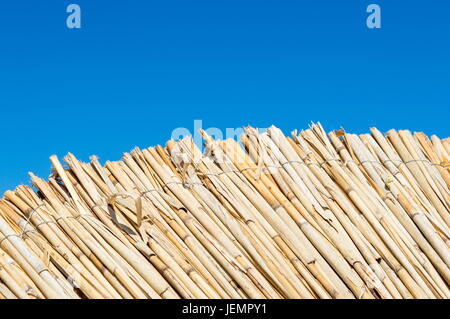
left=0, top=0, right=450, bottom=194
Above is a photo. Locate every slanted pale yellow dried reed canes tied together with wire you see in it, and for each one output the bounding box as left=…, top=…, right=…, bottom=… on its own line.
left=0, top=124, right=450, bottom=299
